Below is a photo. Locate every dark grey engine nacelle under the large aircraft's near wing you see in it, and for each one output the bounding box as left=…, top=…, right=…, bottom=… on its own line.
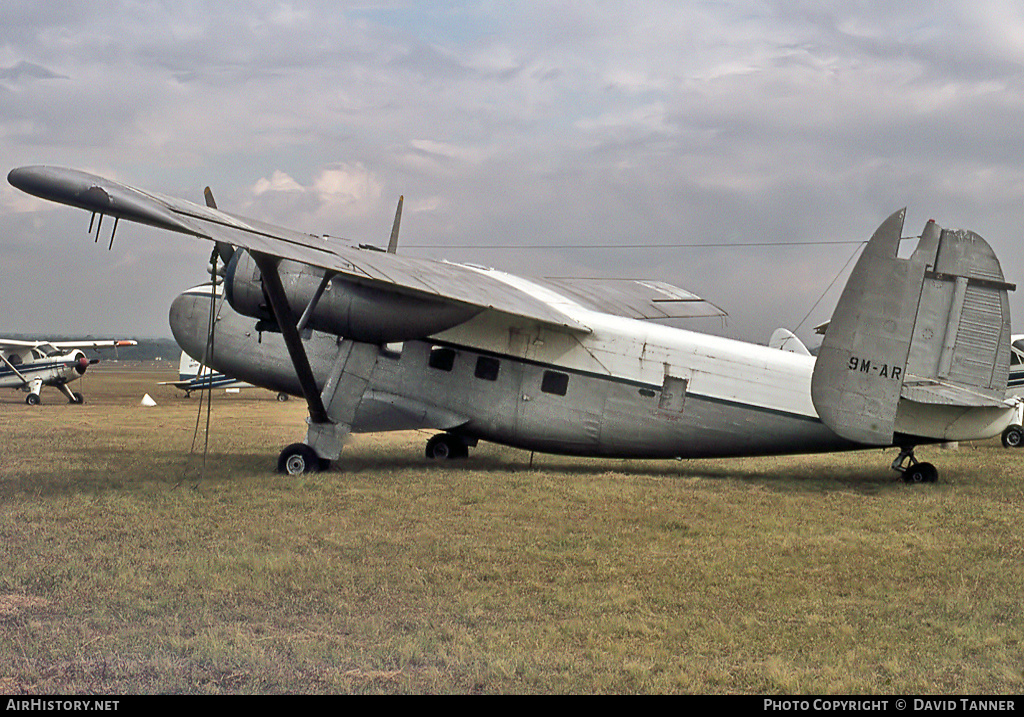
left=224, top=249, right=482, bottom=344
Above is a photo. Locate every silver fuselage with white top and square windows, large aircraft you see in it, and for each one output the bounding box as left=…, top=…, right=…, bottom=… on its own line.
left=170, top=286, right=857, bottom=458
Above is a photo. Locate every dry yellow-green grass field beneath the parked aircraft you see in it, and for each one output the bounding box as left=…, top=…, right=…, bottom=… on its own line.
left=0, top=364, right=1024, bottom=693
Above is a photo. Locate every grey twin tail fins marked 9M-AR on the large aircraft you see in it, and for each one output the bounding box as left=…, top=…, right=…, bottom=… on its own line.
left=811, top=210, right=1015, bottom=446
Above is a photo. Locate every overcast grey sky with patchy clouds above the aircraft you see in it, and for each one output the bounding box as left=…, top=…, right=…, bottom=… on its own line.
left=0, top=0, right=1024, bottom=344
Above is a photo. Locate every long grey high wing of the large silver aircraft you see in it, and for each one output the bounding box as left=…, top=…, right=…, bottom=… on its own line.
left=7, top=166, right=724, bottom=333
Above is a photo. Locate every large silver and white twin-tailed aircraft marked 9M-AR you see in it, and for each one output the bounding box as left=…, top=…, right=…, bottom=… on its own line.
left=8, top=167, right=1019, bottom=482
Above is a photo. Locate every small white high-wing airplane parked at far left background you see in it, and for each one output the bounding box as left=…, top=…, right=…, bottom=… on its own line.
left=0, top=339, right=137, bottom=406
